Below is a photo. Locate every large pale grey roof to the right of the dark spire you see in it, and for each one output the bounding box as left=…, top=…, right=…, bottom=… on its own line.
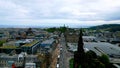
left=84, top=42, right=120, bottom=56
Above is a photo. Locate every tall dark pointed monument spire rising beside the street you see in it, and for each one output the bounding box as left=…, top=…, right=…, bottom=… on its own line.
left=74, top=29, right=85, bottom=68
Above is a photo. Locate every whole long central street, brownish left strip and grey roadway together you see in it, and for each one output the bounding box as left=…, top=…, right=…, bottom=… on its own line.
left=50, top=36, right=73, bottom=68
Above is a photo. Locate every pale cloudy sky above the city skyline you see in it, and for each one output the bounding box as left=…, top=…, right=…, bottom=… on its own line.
left=0, top=0, right=120, bottom=27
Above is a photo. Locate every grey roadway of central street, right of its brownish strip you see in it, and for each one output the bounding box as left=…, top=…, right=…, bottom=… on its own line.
left=59, top=36, right=73, bottom=68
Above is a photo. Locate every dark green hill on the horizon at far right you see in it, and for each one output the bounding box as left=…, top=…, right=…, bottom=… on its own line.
left=90, top=24, right=120, bottom=32
